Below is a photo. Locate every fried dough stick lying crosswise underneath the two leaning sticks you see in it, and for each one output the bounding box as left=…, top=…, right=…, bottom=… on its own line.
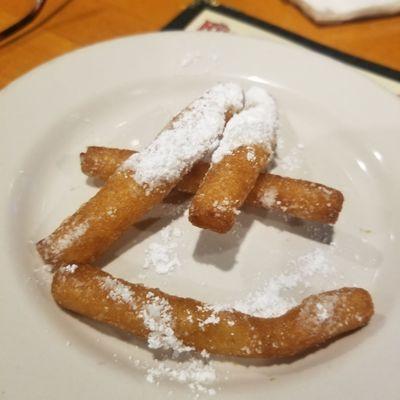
left=80, top=146, right=343, bottom=224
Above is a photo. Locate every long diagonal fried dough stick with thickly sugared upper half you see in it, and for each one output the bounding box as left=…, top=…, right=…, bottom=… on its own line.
left=37, top=84, right=243, bottom=266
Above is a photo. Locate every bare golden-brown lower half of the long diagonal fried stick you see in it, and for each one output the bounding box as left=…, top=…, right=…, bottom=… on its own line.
left=36, top=171, right=174, bottom=266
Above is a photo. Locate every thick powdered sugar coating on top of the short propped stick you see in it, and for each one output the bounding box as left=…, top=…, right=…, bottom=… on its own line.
left=211, top=87, right=278, bottom=163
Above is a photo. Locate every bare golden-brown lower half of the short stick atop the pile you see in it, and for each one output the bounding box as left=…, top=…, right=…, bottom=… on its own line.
left=189, top=145, right=269, bottom=233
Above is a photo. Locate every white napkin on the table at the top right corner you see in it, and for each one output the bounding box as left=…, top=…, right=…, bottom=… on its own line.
left=291, top=0, right=400, bottom=22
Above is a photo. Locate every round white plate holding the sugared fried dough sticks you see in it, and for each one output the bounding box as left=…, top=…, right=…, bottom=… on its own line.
left=0, top=33, right=400, bottom=400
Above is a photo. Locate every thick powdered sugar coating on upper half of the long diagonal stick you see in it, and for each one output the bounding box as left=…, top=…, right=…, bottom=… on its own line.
left=122, top=83, right=243, bottom=190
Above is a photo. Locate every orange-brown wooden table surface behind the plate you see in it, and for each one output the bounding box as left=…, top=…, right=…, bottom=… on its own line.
left=0, top=0, right=400, bottom=88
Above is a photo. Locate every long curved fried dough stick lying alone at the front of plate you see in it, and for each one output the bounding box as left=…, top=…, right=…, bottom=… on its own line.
left=52, top=265, right=374, bottom=358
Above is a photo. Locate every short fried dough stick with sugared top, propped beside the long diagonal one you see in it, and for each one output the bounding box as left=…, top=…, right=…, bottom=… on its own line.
left=189, top=87, right=278, bottom=233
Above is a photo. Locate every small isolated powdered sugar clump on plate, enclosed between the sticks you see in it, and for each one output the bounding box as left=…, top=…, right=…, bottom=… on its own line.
left=143, top=226, right=182, bottom=274
